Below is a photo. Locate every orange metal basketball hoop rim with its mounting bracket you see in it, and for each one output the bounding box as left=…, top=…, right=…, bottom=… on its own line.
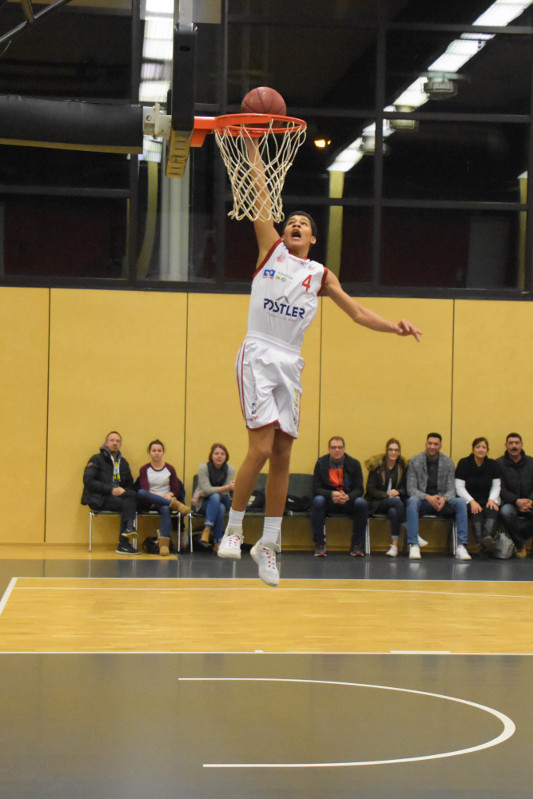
left=191, top=114, right=307, bottom=147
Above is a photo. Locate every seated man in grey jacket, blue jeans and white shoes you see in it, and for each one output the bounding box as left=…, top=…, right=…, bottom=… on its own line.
left=407, top=433, right=471, bottom=560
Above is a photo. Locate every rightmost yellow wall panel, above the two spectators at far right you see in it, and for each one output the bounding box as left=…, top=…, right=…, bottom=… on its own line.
left=452, top=300, right=533, bottom=463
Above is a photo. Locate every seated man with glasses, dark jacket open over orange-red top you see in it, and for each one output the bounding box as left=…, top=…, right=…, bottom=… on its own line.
left=311, top=436, right=368, bottom=558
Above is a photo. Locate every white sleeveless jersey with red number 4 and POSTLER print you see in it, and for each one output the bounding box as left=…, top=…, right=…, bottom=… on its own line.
left=247, top=239, right=328, bottom=353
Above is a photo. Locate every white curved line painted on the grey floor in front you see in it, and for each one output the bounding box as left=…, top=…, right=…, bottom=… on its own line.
left=179, top=677, right=516, bottom=768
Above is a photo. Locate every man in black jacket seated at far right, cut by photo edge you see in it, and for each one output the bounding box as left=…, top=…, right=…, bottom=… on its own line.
left=496, top=433, right=533, bottom=558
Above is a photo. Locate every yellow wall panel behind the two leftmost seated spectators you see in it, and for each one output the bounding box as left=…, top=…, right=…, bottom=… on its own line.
left=46, top=289, right=187, bottom=543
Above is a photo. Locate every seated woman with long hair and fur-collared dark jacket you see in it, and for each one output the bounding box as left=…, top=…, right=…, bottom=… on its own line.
left=365, top=438, right=408, bottom=558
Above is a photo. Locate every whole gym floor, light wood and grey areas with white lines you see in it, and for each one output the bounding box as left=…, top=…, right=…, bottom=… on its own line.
left=0, top=547, right=533, bottom=799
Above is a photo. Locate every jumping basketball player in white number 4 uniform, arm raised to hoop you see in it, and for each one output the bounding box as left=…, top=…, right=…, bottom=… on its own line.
left=217, top=143, right=421, bottom=586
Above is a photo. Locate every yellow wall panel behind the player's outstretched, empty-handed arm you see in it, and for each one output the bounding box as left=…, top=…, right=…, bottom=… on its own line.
left=320, top=298, right=453, bottom=471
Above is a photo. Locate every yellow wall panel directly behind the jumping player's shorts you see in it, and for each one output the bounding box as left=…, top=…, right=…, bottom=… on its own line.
left=185, top=294, right=320, bottom=497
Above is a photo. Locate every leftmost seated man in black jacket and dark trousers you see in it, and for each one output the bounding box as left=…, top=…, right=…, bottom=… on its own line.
left=81, top=430, right=138, bottom=555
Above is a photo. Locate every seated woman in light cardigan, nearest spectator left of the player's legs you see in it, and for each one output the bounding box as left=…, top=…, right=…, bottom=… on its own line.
left=193, top=444, right=235, bottom=552
